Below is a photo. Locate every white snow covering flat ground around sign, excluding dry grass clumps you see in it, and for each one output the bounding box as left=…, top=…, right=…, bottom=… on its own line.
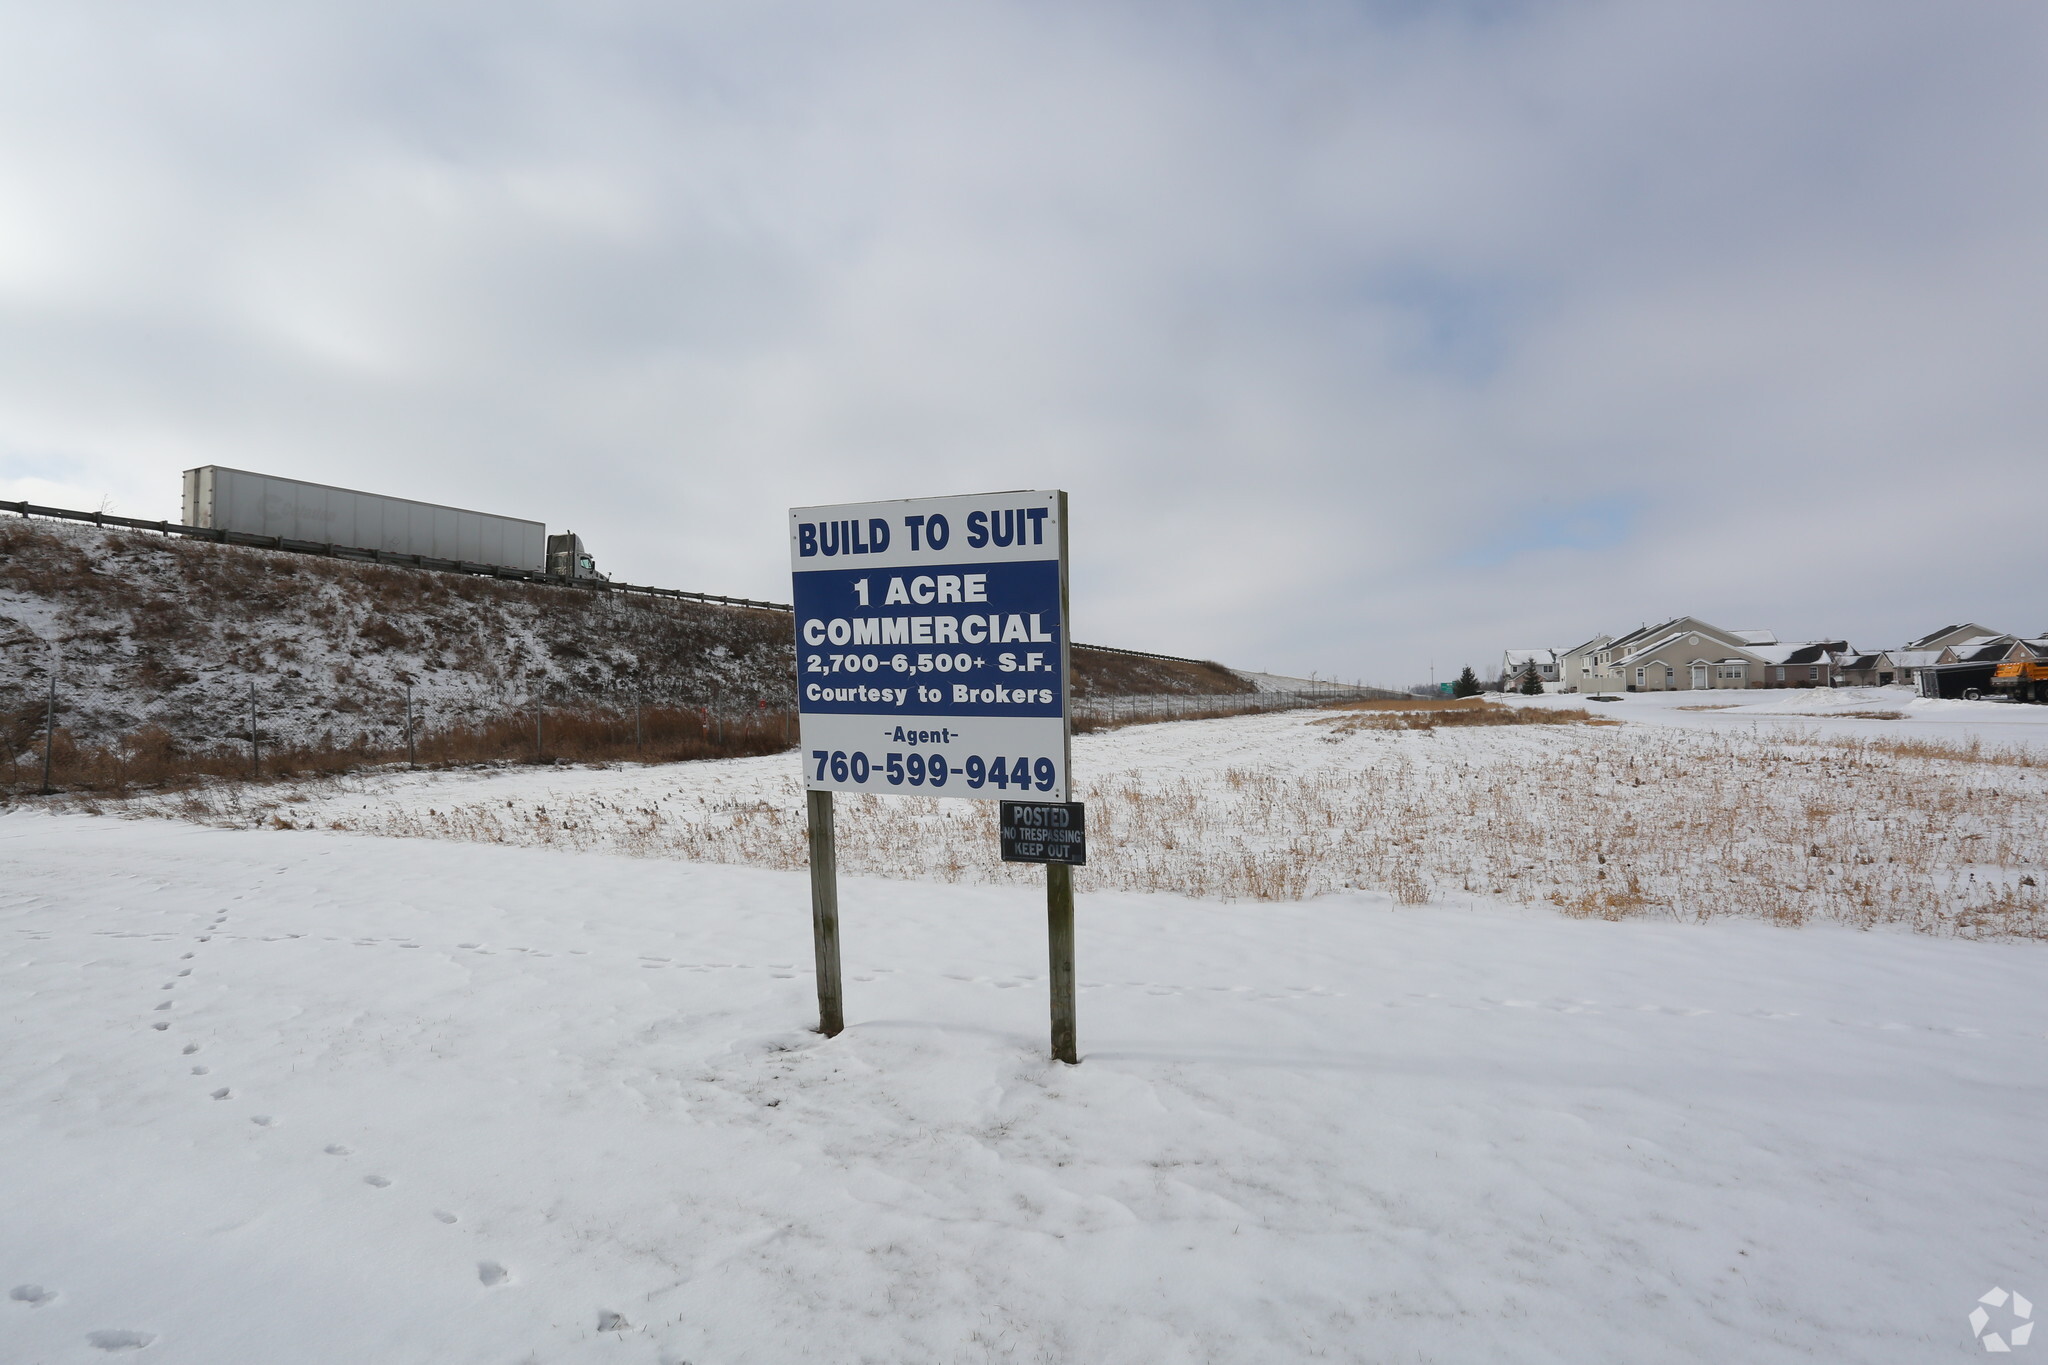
left=0, top=694, right=2048, bottom=1365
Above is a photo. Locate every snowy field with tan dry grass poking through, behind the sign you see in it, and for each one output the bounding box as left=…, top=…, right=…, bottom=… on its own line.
left=109, top=692, right=2048, bottom=937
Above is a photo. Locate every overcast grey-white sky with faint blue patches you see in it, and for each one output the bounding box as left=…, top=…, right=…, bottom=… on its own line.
left=0, top=0, right=2048, bottom=684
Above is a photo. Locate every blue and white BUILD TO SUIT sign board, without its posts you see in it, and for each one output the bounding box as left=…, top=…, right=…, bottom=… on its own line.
left=788, top=491, right=1069, bottom=800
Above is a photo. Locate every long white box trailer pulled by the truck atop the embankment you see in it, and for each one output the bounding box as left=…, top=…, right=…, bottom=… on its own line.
left=184, top=465, right=547, bottom=573
